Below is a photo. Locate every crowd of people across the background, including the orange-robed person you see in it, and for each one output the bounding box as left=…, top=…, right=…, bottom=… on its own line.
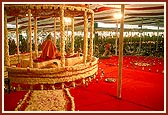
left=9, top=34, right=164, bottom=59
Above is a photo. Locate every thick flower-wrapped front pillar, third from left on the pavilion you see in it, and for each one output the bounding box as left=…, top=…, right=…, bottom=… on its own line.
left=28, top=9, right=33, bottom=68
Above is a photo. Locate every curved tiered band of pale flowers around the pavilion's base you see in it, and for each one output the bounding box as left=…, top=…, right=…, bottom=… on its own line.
left=7, top=58, right=98, bottom=84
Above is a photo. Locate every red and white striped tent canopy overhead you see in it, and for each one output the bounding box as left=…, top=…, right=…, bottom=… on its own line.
left=4, top=2, right=165, bottom=31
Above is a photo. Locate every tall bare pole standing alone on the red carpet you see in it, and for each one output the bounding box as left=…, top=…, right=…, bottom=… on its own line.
left=117, top=4, right=125, bottom=98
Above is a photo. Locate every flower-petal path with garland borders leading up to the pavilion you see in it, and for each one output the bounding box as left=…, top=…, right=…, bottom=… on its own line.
left=15, top=89, right=75, bottom=111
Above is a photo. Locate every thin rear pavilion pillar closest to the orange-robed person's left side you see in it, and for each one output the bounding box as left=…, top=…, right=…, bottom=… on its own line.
left=34, top=17, right=38, bottom=58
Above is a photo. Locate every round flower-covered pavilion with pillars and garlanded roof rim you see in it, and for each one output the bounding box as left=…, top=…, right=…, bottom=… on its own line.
left=4, top=4, right=98, bottom=89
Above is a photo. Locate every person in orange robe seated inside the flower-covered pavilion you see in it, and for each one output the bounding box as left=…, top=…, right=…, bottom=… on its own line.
left=40, top=34, right=58, bottom=60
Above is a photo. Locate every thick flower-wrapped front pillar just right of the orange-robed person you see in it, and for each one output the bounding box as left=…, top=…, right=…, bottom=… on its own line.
left=60, top=6, right=65, bottom=67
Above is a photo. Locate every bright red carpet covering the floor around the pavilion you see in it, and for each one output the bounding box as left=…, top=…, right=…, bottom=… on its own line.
left=4, top=56, right=164, bottom=111
